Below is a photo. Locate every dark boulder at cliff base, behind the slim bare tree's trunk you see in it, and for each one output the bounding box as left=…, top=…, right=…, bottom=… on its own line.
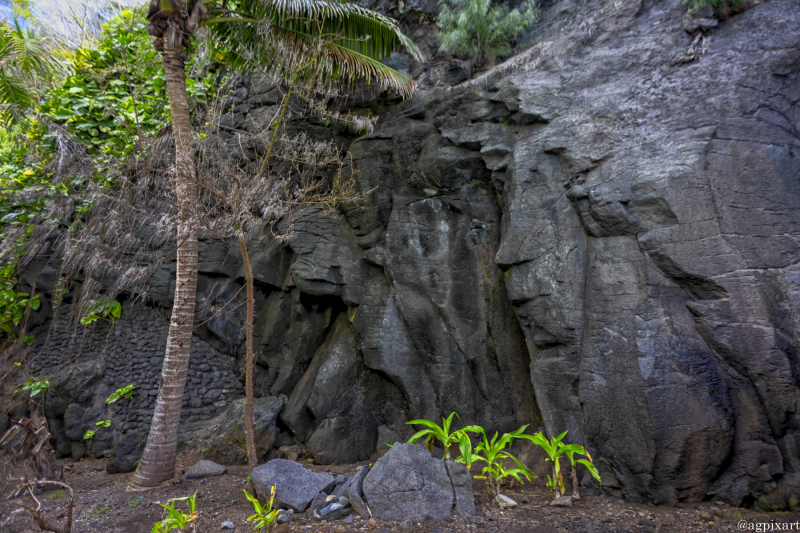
left=203, top=396, right=286, bottom=464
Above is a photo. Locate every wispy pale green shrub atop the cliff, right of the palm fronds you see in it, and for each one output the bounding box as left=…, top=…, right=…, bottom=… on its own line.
left=436, top=0, right=539, bottom=66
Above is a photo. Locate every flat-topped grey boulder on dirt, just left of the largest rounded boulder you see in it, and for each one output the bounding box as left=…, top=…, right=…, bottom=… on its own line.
left=251, top=459, right=336, bottom=513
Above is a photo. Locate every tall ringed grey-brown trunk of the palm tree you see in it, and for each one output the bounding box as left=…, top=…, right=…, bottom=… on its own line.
left=129, top=35, right=198, bottom=489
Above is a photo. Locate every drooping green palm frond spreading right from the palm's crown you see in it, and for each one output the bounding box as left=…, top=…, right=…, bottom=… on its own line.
left=206, top=0, right=420, bottom=97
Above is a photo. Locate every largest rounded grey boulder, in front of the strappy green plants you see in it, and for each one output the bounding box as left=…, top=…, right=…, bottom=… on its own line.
left=364, top=443, right=475, bottom=522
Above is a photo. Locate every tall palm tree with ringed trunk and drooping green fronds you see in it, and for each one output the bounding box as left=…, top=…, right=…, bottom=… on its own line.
left=130, top=0, right=418, bottom=489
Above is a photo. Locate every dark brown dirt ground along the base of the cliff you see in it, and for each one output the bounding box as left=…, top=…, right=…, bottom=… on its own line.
left=0, top=455, right=800, bottom=533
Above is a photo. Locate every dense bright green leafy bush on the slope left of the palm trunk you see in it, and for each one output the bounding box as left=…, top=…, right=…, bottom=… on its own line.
left=0, top=9, right=213, bottom=345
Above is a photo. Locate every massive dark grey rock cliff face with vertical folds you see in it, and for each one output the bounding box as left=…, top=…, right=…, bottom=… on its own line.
left=17, top=0, right=800, bottom=508
